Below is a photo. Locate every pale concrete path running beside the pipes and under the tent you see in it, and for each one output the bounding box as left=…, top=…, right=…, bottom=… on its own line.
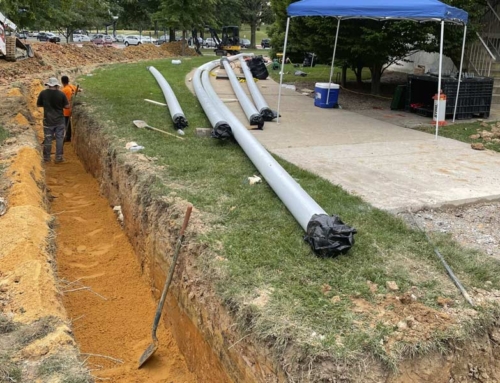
left=212, top=70, right=500, bottom=211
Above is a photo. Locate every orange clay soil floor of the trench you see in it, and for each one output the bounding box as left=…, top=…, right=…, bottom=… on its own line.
left=46, top=143, right=197, bottom=383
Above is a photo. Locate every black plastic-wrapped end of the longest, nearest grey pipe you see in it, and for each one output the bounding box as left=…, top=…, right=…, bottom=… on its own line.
left=304, top=214, right=357, bottom=257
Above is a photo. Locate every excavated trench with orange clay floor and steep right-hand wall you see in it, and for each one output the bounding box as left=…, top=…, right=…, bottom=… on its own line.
left=35, top=84, right=286, bottom=383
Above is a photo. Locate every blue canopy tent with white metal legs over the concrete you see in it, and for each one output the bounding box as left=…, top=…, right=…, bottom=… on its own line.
left=278, top=0, right=468, bottom=138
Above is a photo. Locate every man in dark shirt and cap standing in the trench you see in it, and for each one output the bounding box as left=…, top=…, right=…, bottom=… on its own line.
left=36, top=77, right=69, bottom=163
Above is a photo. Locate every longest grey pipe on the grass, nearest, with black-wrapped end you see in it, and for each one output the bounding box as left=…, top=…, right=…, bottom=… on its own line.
left=198, top=57, right=356, bottom=256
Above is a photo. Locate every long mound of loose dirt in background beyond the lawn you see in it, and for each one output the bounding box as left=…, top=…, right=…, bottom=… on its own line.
left=0, top=42, right=196, bottom=85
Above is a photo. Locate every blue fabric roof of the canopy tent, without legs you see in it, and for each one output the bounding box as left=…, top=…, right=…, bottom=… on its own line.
left=287, top=0, right=468, bottom=24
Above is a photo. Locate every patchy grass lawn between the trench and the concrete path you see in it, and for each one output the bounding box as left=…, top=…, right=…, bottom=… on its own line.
left=79, top=57, right=500, bottom=376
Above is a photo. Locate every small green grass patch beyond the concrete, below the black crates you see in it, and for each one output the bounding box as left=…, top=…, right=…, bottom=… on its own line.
left=416, top=122, right=500, bottom=152
